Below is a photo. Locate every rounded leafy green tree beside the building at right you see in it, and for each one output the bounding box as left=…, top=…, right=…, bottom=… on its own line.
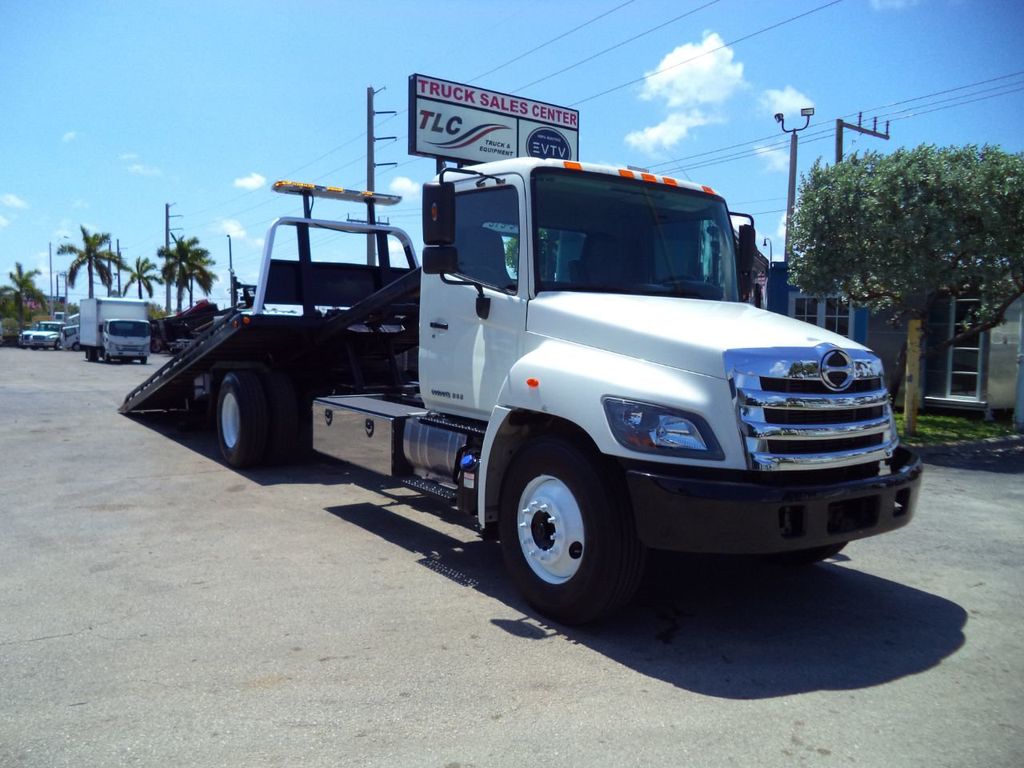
left=790, top=145, right=1024, bottom=423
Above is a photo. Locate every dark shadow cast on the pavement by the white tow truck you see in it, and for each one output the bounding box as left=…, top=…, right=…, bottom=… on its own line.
left=327, top=500, right=967, bottom=699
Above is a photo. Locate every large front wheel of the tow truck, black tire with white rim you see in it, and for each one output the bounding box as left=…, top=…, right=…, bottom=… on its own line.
left=499, top=437, right=646, bottom=625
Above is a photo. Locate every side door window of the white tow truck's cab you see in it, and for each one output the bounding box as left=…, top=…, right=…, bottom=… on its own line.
left=455, top=186, right=519, bottom=292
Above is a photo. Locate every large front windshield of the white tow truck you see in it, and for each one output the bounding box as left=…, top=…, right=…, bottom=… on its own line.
left=534, top=171, right=736, bottom=301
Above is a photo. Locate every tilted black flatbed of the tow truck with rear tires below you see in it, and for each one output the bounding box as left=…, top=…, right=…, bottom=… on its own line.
left=119, top=182, right=420, bottom=467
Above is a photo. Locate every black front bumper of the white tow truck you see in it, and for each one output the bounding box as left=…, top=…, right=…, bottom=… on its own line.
left=626, top=447, right=922, bottom=554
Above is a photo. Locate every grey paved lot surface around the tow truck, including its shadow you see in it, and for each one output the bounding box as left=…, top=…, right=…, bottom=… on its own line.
left=0, top=348, right=1024, bottom=768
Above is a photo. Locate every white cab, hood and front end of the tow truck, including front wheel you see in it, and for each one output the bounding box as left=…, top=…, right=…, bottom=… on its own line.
left=420, top=160, right=921, bottom=618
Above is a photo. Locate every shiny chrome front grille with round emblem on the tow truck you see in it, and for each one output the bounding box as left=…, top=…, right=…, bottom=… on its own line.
left=726, top=344, right=898, bottom=471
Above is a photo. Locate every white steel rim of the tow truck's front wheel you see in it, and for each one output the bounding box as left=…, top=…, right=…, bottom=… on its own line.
left=516, top=475, right=586, bottom=585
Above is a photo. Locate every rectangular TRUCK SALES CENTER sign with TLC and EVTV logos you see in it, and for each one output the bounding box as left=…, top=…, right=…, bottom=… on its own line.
left=409, top=75, right=580, bottom=163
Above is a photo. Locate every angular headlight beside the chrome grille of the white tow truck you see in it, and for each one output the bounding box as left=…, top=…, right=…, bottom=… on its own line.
left=602, top=397, right=725, bottom=459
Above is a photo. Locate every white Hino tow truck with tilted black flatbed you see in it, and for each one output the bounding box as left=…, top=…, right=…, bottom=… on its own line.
left=121, top=159, right=922, bottom=624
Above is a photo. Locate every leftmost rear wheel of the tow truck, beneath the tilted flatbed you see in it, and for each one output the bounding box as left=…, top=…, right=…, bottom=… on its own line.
left=217, top=371, right=268, bottom=469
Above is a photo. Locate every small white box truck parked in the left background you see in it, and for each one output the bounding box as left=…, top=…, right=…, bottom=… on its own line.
left=78, top=298, right=150, bottom=365
